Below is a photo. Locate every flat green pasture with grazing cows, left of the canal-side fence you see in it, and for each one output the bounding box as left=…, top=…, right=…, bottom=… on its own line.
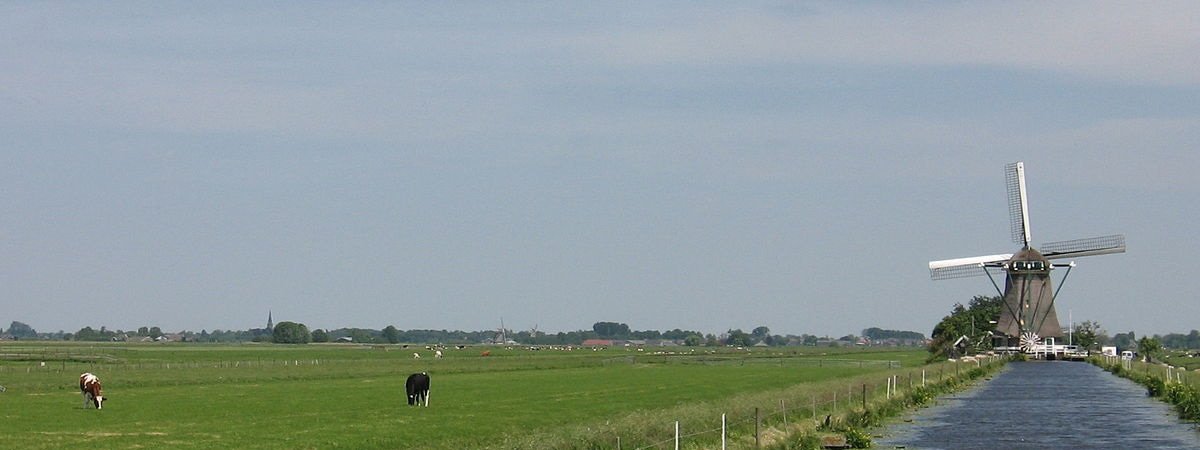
left=0, top=342, right=924, bottom=449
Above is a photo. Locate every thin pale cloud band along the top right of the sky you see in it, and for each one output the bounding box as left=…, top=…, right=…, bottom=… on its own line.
left=578, top=1, right=1200, bottom=85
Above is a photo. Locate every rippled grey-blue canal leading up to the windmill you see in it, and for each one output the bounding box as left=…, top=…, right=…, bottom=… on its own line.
left=875, top=361, right=1200, bottom=450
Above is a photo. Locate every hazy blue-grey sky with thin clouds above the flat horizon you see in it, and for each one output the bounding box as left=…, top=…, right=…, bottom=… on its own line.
left=0, top=1, right=1200, bottom=336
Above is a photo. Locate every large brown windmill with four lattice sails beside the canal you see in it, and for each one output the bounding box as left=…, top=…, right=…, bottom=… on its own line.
left=929, top=162, right=1126, bottom=353
